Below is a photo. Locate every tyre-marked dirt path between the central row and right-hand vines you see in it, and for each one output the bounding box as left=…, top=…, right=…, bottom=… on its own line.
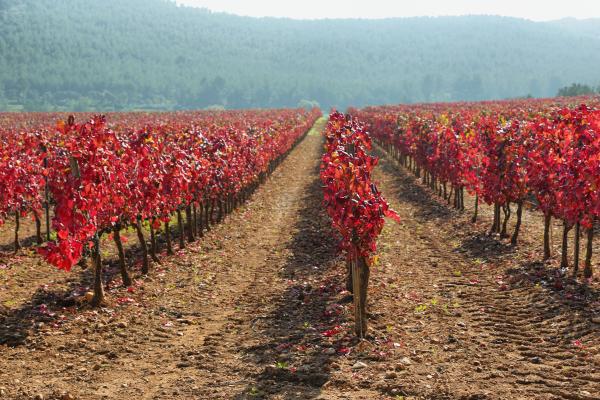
left=330, top=147, right=600, bottom=400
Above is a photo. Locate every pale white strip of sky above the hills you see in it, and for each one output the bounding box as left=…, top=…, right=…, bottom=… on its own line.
left=177, top=0, right=600, bottom=21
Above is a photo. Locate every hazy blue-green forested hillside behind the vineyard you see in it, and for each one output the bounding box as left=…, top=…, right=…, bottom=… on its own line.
left=0, top=0, right=600, bottom=110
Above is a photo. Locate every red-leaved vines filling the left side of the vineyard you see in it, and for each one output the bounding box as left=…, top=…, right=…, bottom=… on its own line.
left=0, top=110, right=320, bottom=304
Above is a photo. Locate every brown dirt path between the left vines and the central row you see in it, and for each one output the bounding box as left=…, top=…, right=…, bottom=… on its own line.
left=0, top=116, right=352, bottom=399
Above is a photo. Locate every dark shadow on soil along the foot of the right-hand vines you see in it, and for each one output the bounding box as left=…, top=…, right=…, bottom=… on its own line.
left=375, top=149, right=600, bottom=341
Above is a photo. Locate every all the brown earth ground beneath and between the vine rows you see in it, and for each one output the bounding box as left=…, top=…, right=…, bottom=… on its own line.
left=0, top=119, right=600, bottom=399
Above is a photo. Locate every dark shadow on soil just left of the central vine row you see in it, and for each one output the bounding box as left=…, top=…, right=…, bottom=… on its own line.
left=235, top=170, right=344, bottom=399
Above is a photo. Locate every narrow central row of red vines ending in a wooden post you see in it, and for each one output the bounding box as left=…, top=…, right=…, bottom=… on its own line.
left=321, top=112, right=400, bottom=337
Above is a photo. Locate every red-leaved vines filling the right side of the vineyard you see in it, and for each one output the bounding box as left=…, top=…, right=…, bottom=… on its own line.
left=351, top=98, right=600, bottom=280
